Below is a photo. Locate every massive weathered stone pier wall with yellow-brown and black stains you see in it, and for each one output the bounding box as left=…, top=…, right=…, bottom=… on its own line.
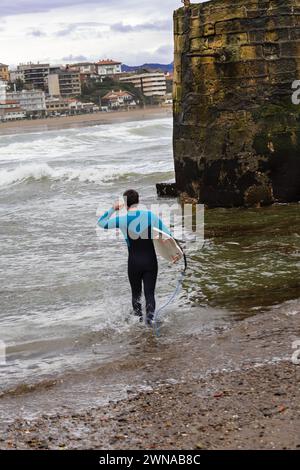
left=174, top=0, right=300, bottom=207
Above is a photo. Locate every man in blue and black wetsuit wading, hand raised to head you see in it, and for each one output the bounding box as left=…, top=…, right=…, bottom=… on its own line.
left=98, top=189, right=171, bottom=325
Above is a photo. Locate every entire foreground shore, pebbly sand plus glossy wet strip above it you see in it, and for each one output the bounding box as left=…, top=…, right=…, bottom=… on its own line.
left=0, top=309, right=300, bottom=449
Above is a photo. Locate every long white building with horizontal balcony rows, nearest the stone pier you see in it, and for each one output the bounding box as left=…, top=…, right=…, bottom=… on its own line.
left=120, top=72, right=167, bottom=97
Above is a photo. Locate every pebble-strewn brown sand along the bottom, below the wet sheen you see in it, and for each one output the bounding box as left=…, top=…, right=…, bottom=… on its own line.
left=0, top=363, right=300, bottom=450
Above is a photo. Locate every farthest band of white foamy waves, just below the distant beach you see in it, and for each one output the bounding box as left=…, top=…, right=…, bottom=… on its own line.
left=0, top=120, right=172, bottom=163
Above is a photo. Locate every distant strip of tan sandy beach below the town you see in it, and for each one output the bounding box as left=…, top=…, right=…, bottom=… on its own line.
left=0, top=106, right=173, bottom=136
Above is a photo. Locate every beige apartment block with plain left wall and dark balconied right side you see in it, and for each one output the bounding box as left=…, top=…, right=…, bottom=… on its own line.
left=47, top=69, right=81, bottom=97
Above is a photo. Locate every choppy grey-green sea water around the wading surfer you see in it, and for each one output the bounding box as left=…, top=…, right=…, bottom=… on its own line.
left=0, top=118, right=300, bottom=414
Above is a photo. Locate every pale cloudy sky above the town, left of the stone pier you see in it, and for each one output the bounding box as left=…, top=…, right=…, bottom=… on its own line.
left=0, top=0, right=188, bottom=65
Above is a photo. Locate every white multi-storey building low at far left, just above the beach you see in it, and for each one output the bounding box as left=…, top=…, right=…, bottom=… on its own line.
left=6, top=90, right=46, bottom=116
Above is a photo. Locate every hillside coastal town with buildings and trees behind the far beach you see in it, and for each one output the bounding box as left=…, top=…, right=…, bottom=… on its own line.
left=0, top=59, right=173, bottom=123
